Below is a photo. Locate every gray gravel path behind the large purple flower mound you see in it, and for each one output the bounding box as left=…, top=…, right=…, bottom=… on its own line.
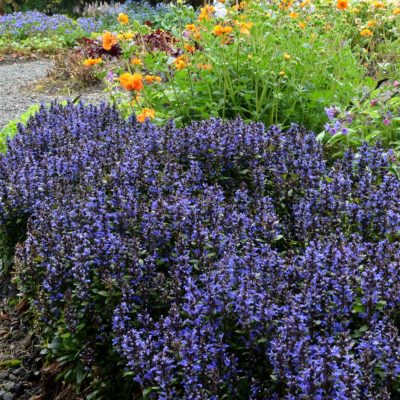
left=0, top=60, right=107, bottom=129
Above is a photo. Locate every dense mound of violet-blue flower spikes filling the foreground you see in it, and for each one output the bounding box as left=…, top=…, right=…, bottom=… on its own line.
left=0, top=104, right=400, bottom=400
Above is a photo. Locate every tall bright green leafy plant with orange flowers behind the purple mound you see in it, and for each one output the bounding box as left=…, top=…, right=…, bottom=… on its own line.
left=105, top=0, right=365, bottom=129
